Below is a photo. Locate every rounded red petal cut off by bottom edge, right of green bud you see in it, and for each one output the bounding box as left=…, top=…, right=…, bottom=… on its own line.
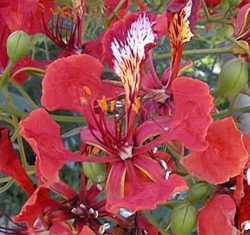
left=198, top=195, right=240, bottom=235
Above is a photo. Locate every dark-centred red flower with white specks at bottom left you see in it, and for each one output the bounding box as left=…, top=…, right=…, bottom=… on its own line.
left=15, top=177, right=109, bottom=234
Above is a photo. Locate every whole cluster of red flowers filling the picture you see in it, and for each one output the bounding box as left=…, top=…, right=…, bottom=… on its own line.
left=0, top=0, right=250, bottom=235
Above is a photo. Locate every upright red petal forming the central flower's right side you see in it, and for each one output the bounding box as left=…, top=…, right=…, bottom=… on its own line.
left=168, top=78, right=213, bottom=151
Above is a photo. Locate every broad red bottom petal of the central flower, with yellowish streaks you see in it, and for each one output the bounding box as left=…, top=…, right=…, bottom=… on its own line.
left=106, top=156, right=187, bottom=213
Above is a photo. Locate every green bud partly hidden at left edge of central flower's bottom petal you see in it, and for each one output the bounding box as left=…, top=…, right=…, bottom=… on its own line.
left=83, top=162, right=106, bottom=184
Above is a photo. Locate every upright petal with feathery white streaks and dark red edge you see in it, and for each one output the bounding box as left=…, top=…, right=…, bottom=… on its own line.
left=103, top=13, right=156, bottom=101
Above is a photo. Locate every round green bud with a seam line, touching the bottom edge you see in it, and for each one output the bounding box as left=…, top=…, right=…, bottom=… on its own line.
left=170, top=204, right=197, bottom=235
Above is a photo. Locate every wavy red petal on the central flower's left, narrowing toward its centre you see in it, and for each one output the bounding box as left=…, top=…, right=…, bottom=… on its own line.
left=20, top=109, right=84, bottom=182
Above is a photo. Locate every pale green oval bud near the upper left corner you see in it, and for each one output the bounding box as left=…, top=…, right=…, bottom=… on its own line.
left=7, top=31, right=31, bottom=63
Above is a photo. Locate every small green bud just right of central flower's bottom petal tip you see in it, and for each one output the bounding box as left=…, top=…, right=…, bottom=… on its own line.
left=188, top=183, right=211, bottom=203
